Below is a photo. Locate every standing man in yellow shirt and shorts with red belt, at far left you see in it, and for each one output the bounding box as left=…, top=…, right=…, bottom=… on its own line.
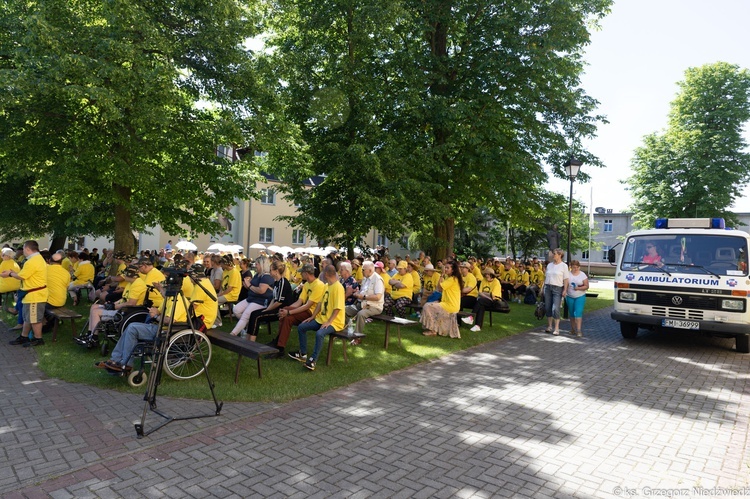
left=0, top=240, right=49, bottom=347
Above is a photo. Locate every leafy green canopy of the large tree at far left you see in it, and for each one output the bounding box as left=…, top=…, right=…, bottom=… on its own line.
left=0, top=0, right=264, bottom=250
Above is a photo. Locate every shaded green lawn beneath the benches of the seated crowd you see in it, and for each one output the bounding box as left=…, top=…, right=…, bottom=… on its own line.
left=1, top=288, right=613, bottom=402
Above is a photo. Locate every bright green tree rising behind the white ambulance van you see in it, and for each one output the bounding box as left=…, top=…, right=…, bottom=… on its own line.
left=627, top=62, right=750, bottom=230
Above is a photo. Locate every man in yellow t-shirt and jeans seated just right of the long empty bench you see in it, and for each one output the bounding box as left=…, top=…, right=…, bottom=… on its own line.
left=289, top=265, right=346, bottom=371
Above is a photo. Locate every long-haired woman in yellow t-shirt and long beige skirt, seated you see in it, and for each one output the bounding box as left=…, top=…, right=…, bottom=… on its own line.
left=420, top=260, right=465, bottom=338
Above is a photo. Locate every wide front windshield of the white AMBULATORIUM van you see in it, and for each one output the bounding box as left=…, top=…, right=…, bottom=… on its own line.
left=620, top=233, right=747, bottom=276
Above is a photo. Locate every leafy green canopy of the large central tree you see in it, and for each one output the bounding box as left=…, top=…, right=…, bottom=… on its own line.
left=262, top=0, right=610, bottom=257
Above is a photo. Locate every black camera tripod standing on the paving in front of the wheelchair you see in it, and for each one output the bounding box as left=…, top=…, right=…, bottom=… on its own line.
left=135, top=277, right=224, bottom=438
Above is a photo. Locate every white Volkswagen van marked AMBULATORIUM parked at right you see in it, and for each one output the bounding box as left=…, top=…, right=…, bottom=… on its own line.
left=609, top=218, right=750, bottom=353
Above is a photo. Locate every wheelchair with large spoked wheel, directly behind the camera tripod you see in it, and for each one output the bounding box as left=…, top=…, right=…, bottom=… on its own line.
left=116, top=324, right=211, bottom=388
